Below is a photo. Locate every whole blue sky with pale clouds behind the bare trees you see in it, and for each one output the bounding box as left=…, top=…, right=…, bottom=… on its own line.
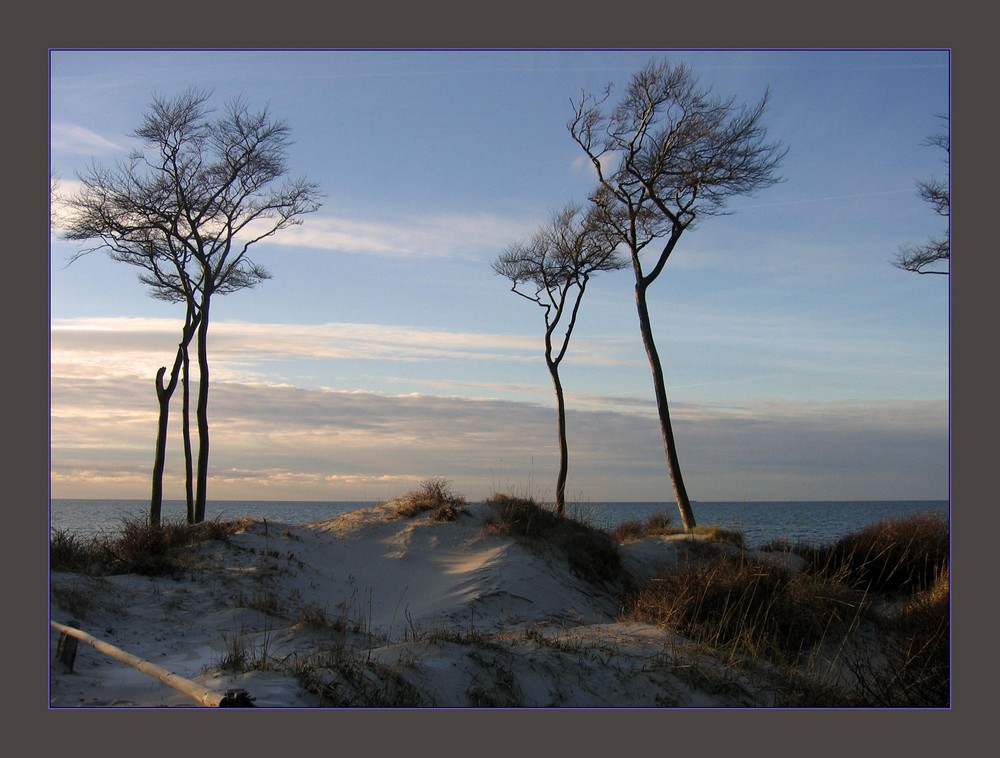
left=49, top=50, right=950, bottom=502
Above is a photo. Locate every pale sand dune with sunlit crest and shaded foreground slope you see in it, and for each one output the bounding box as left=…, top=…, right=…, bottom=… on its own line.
left=50, top=504, right=796, bottom=708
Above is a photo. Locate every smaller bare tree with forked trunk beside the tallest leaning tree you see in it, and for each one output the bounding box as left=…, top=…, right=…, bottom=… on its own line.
left=493, top=205, right=628, bottom=516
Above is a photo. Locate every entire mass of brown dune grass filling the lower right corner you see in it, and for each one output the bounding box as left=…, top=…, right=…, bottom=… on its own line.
left=624, top=515, right=950, bottom=707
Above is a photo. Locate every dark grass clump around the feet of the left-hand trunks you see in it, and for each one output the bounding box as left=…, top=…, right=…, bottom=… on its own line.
left=49, top=516, right=249, bottom=576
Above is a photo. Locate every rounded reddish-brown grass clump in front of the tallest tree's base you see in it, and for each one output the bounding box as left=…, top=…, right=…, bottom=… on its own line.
left=625, top=553, right=862, bottom=663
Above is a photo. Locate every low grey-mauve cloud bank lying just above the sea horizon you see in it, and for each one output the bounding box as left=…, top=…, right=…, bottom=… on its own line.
left=52, top=362, right=948, bottom=502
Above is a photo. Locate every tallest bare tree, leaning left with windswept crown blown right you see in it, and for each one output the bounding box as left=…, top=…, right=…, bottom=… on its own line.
left=567, top=61, right=786, bottom=530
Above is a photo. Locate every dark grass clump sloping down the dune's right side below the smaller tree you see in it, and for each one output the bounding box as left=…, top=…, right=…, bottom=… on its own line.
left=483, top=493, right=624, bottom=583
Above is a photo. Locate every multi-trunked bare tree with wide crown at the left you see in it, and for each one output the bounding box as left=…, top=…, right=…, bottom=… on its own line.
left=65, top=89, right=319, bottom=523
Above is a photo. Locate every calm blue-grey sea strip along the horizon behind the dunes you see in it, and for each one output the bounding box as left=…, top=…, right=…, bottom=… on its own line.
left=49, top=499, right=949, bottom=546
